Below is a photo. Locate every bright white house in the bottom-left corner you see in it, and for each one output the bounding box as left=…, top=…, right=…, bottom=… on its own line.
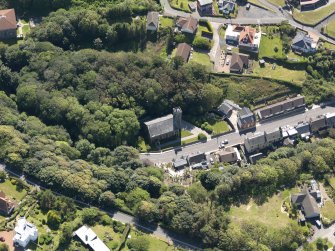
left=13, top=217, right=38, bottom=248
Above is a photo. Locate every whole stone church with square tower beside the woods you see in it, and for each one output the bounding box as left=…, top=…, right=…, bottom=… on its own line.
left=144, top=108, right=182, bottom=143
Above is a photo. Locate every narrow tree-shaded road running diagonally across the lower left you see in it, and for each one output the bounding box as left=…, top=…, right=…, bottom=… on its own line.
left=0, top=164, right=202, bottom=250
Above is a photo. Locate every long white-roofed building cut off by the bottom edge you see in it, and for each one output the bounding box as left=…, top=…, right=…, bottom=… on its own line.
left=74, top=225, right=110, bottom=251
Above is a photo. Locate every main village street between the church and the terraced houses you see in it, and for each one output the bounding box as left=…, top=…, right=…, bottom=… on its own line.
left=141, top=103, right=335, bottom=164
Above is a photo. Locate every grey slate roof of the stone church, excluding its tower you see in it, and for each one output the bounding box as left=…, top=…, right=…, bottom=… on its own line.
left=144, top=114, right=175, bottom=138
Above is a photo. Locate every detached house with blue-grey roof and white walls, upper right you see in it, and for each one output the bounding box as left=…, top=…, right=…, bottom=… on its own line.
left=291, top=32, right=317, bottom=54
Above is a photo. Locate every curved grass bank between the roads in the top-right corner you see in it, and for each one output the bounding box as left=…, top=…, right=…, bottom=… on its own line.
left=293, top=2, right=335, bottom=25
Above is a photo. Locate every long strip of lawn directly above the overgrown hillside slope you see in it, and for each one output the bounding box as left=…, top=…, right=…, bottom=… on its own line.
left=253, top=62, right=307, bottom=84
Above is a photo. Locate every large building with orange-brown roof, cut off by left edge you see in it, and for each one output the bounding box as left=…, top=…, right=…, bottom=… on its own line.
left=0, top=9, right=17, bottom=39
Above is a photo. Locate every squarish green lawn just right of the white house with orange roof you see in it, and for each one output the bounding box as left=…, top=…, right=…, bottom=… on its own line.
left=259, top=35, right=283, bottom=58
